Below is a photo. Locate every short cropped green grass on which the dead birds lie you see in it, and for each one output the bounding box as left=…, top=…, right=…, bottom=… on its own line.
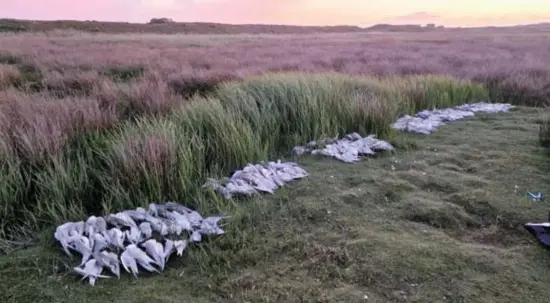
left=0, top=108, right=550, bottom=303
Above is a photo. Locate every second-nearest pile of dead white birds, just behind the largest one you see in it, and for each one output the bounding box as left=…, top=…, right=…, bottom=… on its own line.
left=202, top=160, right=308, bottom=199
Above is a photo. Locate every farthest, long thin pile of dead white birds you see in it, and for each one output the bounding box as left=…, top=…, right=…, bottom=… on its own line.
left=392, top=102, right=514, bottom=135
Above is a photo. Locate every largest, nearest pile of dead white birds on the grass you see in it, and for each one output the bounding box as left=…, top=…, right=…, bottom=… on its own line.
left=54, top=202, right=224, bottom=286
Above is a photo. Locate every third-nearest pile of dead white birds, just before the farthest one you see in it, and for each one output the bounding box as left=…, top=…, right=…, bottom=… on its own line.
left=293, top=133, right=395, bottom=163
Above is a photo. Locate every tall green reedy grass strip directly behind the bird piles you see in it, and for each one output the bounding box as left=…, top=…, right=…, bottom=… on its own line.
left=0, top=74, right=488, bottom=238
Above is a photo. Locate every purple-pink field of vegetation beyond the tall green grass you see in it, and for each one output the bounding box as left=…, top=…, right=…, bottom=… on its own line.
left=0, top=30, right=550, bottom=105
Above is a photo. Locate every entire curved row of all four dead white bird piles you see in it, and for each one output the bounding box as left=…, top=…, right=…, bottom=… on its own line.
left=54, top=103, right=512, bottom=285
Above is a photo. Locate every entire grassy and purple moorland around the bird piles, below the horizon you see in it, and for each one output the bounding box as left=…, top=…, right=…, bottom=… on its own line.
left=0, top=25, right=550, bottom=302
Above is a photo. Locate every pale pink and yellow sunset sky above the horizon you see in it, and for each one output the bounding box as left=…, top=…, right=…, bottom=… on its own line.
left=0, top=0, right=550, bottom=26
